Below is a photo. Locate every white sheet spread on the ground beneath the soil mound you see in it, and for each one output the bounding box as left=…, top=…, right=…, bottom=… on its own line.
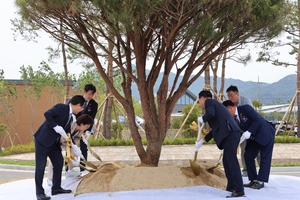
left=0, top=175, right=300, bottom=200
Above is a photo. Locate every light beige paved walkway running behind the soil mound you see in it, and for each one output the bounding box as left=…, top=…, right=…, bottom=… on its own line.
left=0, top=143, right=300, bottom=166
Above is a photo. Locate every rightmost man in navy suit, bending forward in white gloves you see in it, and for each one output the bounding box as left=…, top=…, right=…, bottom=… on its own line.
left=223, top=100, right=275, bottom=189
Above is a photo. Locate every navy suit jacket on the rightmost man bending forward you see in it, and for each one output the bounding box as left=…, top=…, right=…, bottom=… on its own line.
left=237, top=105, right=275, bottom=145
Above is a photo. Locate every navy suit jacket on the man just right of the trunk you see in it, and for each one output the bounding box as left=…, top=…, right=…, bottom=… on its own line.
left=203, top=99, right=240, bottom=149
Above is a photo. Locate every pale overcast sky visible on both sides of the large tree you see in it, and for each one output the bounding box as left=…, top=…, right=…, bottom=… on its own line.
left=0, top=0, right=296, bottom=83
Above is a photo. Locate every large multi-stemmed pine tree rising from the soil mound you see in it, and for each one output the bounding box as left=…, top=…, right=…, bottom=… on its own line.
left=15, top=0, right=287, bottom=166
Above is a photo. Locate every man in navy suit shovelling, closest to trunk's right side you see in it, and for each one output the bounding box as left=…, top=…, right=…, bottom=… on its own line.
left=195, top=90, right=245, bottom=198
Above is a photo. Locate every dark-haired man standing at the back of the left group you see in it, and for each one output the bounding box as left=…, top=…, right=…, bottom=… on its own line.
left=76, top=83, right=98, bottom=171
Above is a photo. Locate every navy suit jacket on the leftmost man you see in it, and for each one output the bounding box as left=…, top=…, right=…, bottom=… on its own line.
left=34, top=104, right=70, bottom=147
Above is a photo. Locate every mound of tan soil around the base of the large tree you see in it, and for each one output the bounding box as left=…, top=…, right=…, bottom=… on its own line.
left=76, top=161, right=227, bottom=194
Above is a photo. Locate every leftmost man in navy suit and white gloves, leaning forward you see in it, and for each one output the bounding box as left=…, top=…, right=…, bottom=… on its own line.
left=34, top=95, right=85, bottom=200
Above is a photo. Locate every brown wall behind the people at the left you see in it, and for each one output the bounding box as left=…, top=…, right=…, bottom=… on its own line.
left=0, top=81, right=73, bottom=148
